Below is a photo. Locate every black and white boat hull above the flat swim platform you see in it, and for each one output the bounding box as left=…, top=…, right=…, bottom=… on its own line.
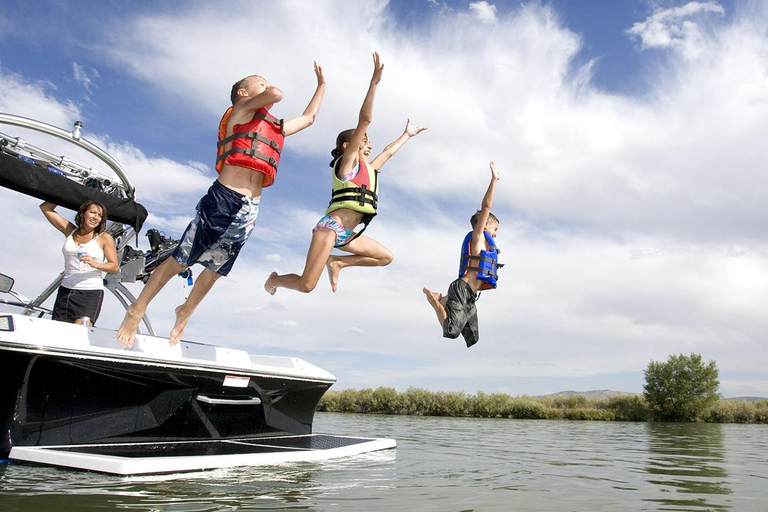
left=0, top=315, right=333, bottom=458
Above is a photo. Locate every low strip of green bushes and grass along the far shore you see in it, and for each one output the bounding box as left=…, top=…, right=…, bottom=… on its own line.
left=318, top=388, right=768, bottom=423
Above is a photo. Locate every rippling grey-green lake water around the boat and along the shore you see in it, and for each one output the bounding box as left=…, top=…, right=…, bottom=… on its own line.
left=0, top=413, right=768, bottom=512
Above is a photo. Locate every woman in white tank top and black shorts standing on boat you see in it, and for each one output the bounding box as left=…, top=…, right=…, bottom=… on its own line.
left=40, top=199, right=119, bottom=325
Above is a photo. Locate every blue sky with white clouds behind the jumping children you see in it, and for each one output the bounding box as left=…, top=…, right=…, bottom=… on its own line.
left=0, top=0, right=768, bottom=397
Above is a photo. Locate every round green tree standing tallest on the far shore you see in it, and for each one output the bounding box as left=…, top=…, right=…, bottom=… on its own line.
left=643, top=353, right=720, bottom=421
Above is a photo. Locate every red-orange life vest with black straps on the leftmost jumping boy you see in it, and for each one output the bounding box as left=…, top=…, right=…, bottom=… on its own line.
left=216, top=107, right=285, bottom=187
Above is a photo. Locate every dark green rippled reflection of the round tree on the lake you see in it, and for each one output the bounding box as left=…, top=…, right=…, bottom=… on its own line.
left=646, top=423, right=733, bottom=511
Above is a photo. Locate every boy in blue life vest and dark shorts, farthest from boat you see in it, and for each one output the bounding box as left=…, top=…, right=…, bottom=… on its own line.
left=423, top=162, right=502, bottom=348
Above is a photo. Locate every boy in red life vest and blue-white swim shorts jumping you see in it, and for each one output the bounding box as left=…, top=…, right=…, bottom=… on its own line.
left=117, top=63, right=325, bottom=347
